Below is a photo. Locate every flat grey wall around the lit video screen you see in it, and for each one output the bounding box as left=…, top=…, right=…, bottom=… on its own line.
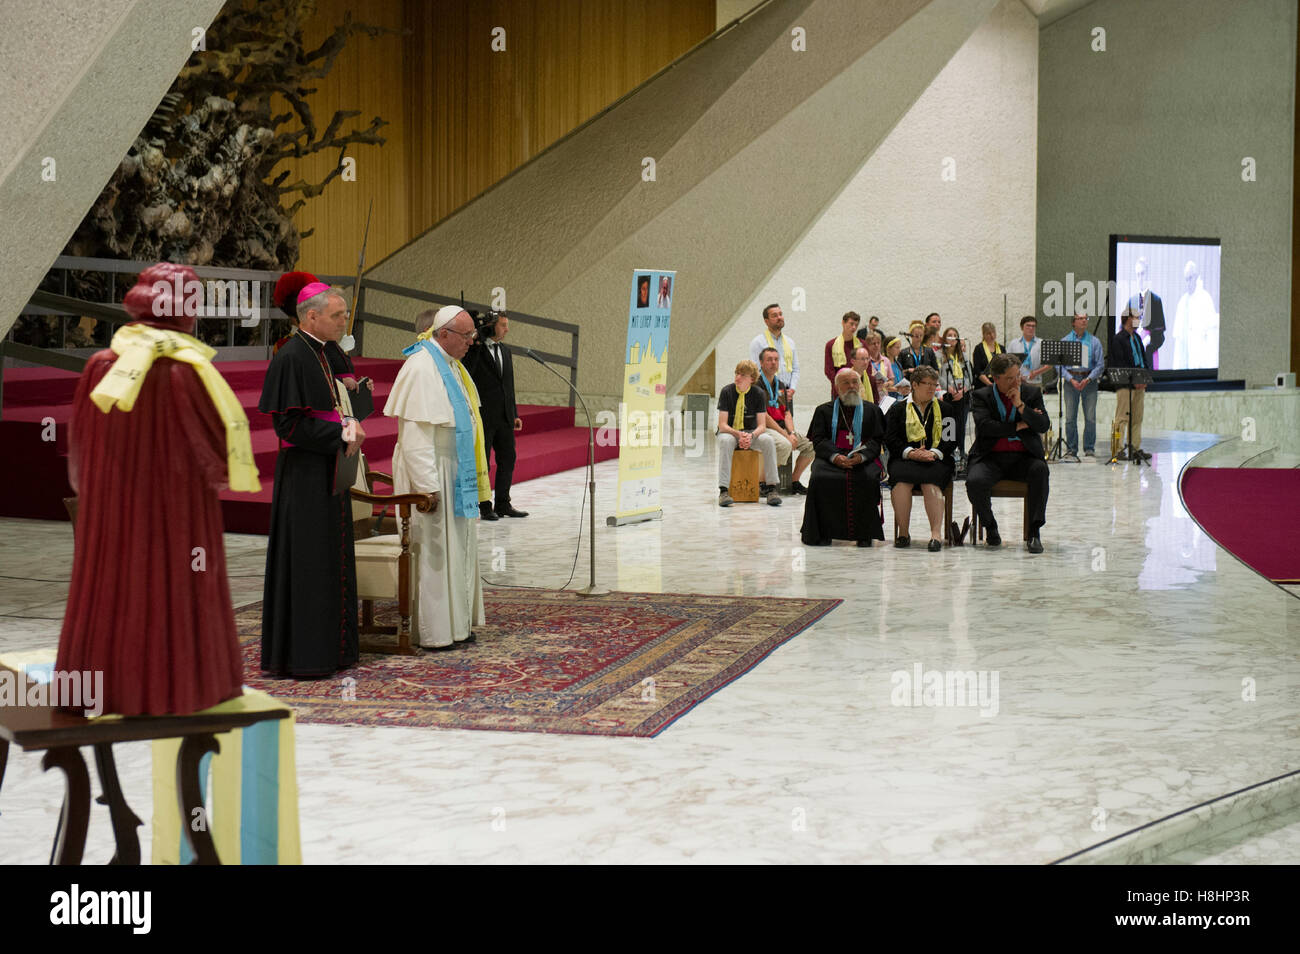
left=1037, top=0, right=1296, bottom=386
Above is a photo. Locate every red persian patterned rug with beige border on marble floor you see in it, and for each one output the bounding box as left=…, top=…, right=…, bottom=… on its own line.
left=235, top=589, right=841, bottom=737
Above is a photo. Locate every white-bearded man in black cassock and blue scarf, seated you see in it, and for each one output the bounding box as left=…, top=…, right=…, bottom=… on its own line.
left=800, top=368, right=885, bottom=547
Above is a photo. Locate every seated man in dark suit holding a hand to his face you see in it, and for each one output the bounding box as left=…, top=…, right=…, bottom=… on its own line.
left=966, top=354, right=1052, bottom=554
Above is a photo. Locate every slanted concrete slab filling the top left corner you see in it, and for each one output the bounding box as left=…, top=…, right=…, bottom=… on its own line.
left=0, top=0, right=222, bottom=335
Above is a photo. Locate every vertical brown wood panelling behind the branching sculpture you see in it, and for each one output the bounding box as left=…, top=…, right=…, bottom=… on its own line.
left=275, top=0, right=715, bottom=276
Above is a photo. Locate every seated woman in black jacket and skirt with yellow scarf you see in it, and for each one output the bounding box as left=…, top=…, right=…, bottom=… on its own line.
left=885, top=368, right=957, bottom=552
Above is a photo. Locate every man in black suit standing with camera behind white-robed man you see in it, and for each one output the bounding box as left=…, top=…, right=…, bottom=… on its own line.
left=464, top=312, right=528, bottom=520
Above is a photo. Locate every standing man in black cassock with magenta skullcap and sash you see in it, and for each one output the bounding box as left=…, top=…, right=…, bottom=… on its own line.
left=257, top=286, right=364, bottom=678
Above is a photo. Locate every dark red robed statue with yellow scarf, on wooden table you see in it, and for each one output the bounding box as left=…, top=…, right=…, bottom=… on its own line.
left=57, top=264, right=257, bottom=715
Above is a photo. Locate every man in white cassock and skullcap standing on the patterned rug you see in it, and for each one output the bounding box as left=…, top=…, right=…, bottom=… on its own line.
left=384, top=305, right=490, bottom=647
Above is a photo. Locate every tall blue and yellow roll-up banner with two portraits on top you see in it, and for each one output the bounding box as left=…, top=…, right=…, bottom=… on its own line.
left=607, top=268, right=677, bottom=525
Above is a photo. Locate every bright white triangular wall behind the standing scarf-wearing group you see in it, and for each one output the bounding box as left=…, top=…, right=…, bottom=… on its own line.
left=716, top=0, right=1039, bottom=408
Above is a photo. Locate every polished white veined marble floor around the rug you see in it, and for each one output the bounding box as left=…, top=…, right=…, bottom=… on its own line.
left=0, top=432, right=1300, bottom=863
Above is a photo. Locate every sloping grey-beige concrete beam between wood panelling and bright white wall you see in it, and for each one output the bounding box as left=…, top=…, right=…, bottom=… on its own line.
left=365, top=0, right=996, bottom=400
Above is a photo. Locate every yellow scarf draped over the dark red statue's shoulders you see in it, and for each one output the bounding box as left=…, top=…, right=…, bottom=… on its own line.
left=90, top=325, right=261, bottom=494
